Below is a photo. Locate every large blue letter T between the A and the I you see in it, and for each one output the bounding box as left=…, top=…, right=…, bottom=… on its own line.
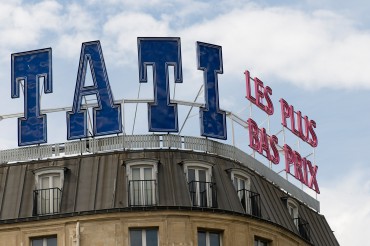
left=138, top=38, right=182, bottom=132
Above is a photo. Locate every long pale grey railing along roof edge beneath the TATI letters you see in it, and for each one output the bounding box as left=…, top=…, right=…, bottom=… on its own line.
left=0, top=134, right=320, bottom=211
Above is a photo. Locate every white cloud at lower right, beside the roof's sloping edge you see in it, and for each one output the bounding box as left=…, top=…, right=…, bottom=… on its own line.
left=320, top=168, right=370, bottom=245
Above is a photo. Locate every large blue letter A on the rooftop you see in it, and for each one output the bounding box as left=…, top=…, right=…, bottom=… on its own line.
left=67, top=41, right=122, bottom=140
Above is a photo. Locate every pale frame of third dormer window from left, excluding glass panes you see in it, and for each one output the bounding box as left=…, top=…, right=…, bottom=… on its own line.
left=183, top=161, right=214, bottom=207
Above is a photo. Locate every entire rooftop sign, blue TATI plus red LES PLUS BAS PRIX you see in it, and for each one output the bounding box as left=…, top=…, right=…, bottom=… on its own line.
left=11, top=38, right=320, bottom=193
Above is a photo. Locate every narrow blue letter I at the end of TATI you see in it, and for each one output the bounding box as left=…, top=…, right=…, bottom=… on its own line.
left=197, top=42, right=227, bottom=139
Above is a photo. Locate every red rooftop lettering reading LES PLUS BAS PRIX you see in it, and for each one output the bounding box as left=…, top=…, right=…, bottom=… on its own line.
left=245, top=71, right=320, bottom=193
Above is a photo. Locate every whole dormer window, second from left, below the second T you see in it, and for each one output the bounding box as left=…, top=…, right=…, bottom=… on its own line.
left=125, top=159, right=158, bottom=206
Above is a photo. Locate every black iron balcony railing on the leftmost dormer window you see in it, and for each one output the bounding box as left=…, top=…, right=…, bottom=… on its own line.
left=33, top=188, right=62, bottom=215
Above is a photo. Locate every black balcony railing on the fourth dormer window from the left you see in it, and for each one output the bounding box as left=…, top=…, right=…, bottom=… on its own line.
left=238, top=189, right=261, bottom=217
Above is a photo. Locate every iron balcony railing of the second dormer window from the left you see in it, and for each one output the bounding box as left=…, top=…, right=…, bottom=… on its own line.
left=128, top=180, right=157, bottom=206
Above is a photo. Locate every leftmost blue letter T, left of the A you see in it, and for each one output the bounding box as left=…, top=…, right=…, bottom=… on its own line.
left=11, top=48, right=53, bottom=146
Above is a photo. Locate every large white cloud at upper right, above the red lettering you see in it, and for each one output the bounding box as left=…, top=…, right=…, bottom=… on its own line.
left=181, top=5, right=370, bottom=88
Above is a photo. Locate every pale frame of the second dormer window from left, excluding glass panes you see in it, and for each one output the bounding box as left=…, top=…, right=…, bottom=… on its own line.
left=125, top=159, right=159, bottom=206
